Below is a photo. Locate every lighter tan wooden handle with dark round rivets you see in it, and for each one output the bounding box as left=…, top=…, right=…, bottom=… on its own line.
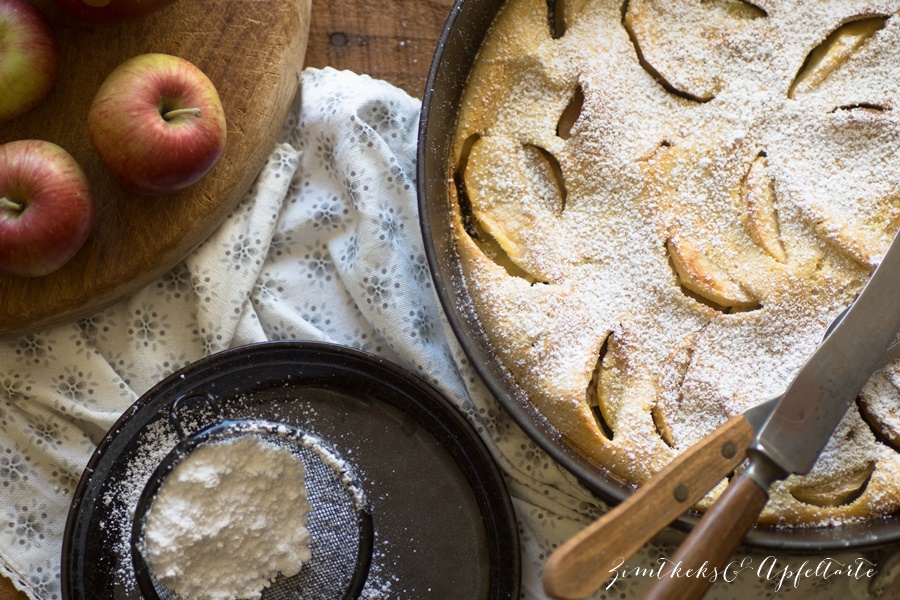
left=543, top=415, right=755, bottom=600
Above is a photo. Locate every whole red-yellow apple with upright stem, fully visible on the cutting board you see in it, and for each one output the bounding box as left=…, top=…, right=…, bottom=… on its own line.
left=88, top=54, right=226, bottom=195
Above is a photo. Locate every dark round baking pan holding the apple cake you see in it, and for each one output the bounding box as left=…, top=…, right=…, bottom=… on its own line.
left=416, top=0, right=900, bottom=552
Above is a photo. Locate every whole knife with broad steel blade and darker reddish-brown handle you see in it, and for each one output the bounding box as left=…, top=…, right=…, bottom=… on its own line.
left=645, top=231, right=900, bottom=600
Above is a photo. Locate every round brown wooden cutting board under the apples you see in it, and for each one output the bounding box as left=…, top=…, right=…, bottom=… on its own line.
left=0, top=0, right=311, bottom=336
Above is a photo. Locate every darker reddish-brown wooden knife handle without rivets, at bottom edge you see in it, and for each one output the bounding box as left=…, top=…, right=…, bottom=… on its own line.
left=644, top=475, right=768, bottom=600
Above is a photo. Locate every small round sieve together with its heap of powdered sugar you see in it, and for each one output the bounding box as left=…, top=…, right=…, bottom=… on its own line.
left=131, top=395, right=373, bottom=600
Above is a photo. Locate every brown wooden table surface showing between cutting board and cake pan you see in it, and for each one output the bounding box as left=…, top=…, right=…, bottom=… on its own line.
left=0, top=0, right=453, bottom=600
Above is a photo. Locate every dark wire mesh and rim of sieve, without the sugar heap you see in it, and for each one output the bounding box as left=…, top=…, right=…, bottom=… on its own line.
left=131, top=393, right=373, bottom=600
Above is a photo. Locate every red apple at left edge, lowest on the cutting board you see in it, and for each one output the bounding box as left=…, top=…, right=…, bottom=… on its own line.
left=0, top=140, right=94, bottom=277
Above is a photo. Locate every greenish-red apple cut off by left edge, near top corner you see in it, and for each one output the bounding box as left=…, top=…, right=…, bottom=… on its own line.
left=0, top=0, right=59, bottom=121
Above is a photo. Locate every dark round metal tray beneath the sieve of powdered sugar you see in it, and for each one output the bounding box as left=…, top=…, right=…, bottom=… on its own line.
left=62, top=342, right=521, bottom=600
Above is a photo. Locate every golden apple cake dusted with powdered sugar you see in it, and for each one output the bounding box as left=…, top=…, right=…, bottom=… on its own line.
left=449, top=0, right=900, bottom=526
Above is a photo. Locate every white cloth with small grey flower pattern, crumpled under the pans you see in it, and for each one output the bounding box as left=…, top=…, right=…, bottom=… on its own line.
left=0, top=69, right=896, bottom=599
